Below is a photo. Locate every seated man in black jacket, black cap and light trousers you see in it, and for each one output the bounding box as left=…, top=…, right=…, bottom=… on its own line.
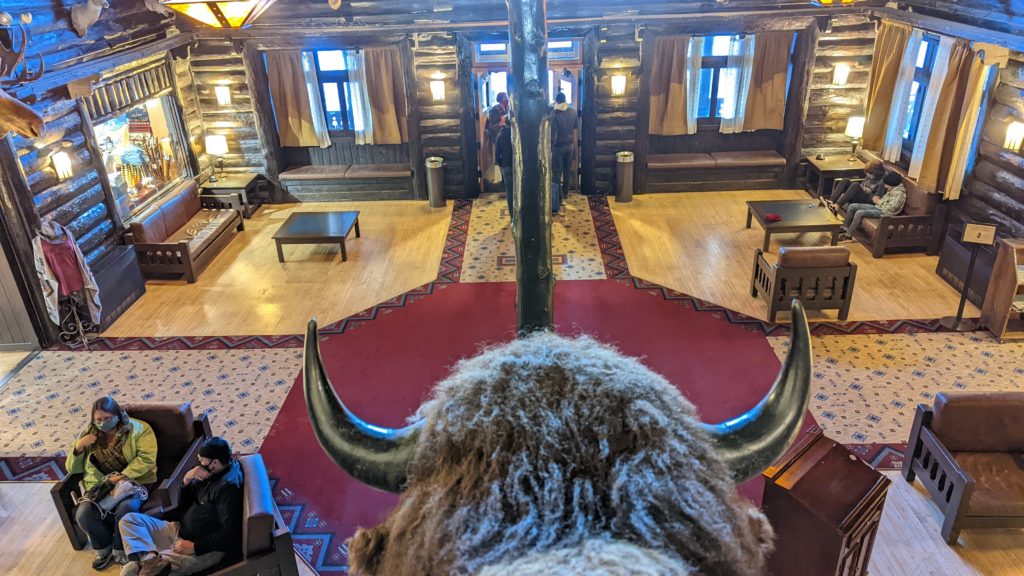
left=119, top=436, right=244, bottom=576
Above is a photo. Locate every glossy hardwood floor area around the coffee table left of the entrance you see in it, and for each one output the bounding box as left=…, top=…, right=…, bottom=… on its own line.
left=103, top=201, right=453, bottom=336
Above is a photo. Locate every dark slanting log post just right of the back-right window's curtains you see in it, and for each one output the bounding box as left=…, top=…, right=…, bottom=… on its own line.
left=778, top=20, right=827, bottom=187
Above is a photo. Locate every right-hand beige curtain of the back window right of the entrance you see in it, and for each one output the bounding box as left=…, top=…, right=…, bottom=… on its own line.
left=743, top=32, right=793, bottom=130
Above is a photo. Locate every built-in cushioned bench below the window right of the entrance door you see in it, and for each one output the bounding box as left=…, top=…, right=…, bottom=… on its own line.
left=642, top=151, right=785, bottom=192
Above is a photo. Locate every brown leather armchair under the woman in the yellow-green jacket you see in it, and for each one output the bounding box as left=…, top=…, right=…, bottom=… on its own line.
left=50, top=402, right=213, bottom=550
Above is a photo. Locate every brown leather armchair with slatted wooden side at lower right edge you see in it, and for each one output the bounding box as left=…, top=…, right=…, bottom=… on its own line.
left=903, top=393, right=1024, bottom=544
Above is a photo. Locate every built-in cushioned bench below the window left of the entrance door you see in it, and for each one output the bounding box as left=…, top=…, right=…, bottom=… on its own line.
left=281, top=164, right=414, bottom=202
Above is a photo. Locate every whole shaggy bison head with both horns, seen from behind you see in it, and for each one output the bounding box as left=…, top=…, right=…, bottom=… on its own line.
left=303, top=297, right=811, bottom=576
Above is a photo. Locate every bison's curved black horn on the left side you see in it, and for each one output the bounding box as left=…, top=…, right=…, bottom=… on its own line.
left=302, top=318, right=422, bottom=492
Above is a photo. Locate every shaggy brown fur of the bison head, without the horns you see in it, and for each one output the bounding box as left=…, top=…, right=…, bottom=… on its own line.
left=349, top=334, right=772, bottom=576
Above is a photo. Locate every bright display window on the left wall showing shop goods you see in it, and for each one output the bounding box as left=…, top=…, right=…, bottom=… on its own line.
left=93, top=95, right=188, bottom=221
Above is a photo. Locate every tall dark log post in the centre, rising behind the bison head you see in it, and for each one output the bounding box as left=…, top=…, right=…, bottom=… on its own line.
left=506, top=0, right=555, bottom=334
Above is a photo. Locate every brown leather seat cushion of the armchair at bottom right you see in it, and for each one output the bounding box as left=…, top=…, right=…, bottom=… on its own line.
left=953, top=452, right=1024, bottom=517
